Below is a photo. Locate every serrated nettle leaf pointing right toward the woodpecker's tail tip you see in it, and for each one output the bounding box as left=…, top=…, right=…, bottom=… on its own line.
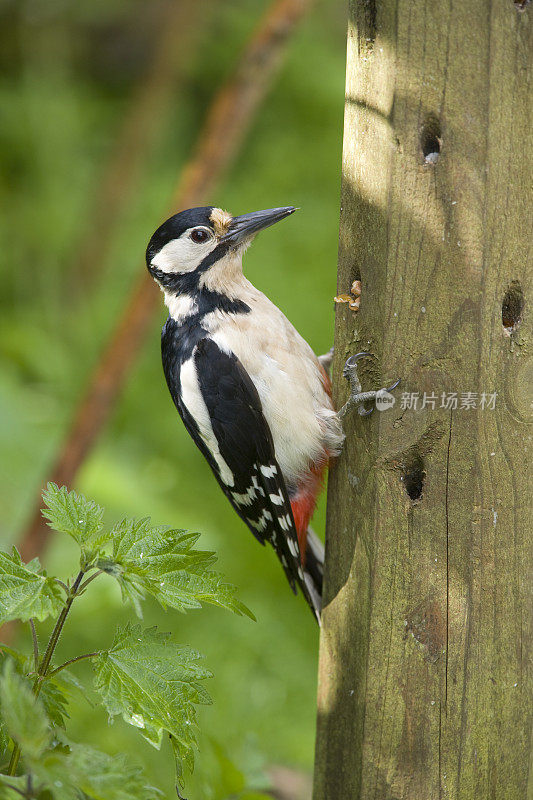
left=105, top=519, right=255, bottom=619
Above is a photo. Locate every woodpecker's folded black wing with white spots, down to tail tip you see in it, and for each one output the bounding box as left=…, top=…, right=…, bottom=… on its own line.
left=162, top=318, right=321, bottom=621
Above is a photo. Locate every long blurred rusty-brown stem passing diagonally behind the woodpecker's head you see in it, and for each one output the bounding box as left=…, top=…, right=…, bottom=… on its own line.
left=20, top=0, right=312, bottom=560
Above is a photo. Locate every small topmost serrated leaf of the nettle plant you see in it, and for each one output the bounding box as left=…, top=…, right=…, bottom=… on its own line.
left=43, top=483, right=110, bottom=550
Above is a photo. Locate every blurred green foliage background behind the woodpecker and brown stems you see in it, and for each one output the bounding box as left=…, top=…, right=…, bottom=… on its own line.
left=0, top=0, right=345, bottom=798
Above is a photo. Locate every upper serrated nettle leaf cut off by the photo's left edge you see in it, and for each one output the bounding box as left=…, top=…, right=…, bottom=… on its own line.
left=0, top=547, right=63, bottom=625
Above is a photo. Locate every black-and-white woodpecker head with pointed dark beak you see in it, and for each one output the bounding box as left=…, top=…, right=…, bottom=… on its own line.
left=146, top=206, right=296, bottom=294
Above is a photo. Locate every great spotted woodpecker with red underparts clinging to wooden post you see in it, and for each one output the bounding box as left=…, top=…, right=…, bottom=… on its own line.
left=146, top=206, right=394, bottom=620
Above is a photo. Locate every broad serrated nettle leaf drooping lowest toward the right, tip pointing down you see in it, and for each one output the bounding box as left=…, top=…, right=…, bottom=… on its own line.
left=93, top=625, right=211, bottom=780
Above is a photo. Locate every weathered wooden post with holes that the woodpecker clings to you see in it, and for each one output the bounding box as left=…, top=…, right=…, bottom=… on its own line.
left=314, top=0, right=533, bottom=800
